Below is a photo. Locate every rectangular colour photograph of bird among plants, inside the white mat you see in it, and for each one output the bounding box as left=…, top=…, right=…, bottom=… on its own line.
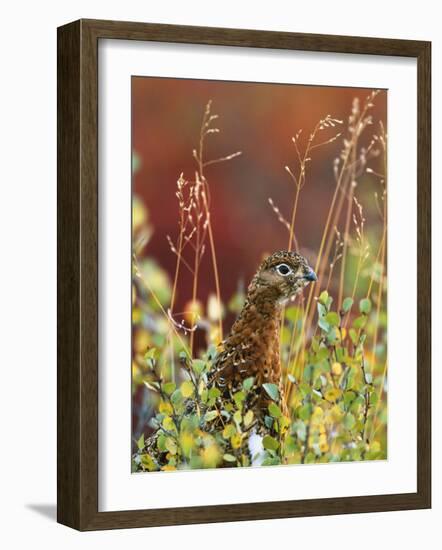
left=130, top=76, right=388, bottom=475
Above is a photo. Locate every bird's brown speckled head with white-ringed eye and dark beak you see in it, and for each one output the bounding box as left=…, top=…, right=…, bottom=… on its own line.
left=252, top=250, right=317, bottom=305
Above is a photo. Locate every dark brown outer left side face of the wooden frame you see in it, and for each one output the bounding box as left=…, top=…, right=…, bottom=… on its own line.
left=57, top=22, right=81, bottom=527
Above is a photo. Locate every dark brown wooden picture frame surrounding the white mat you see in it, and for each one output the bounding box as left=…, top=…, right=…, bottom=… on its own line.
left=57, top=20, right=431, bottom=531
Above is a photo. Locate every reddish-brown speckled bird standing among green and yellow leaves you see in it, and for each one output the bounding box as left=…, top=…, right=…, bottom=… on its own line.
left=208, top=250, right=317, bottom=417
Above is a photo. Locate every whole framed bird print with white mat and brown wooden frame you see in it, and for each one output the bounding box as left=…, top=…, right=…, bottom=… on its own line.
left=58, top=20, right=431, bottom=530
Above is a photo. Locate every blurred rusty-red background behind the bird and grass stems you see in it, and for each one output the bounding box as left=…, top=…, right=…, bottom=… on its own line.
left=132, top=77, right=387, bottom=328
